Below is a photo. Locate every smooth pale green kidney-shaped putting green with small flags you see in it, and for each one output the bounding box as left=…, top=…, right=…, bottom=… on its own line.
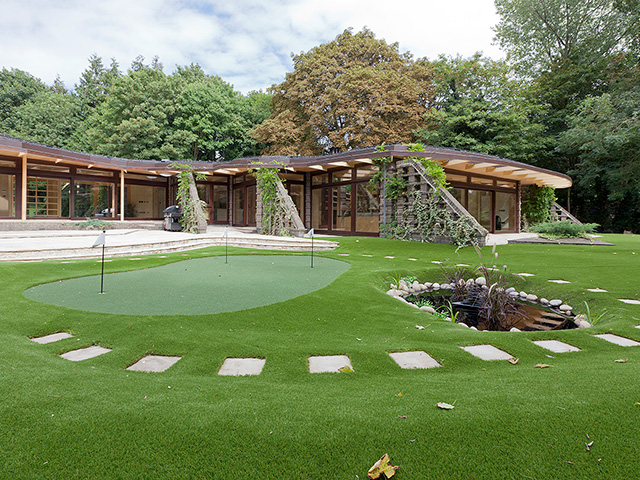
left=24, top=255, right=349, bottom=315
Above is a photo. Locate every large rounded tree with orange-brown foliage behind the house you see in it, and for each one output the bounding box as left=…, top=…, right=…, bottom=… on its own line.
left=253, top=29, right=433, bottom=155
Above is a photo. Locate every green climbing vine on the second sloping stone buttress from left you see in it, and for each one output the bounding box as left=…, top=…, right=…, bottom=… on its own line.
left=249, top=162, right=291, bottom=236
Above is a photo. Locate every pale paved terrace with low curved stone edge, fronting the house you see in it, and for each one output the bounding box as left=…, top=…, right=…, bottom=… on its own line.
left=0, top=222, right=338, bottom=262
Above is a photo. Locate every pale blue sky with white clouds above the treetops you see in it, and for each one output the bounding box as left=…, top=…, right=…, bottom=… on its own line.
left=0, top=0, right=504, bottom=93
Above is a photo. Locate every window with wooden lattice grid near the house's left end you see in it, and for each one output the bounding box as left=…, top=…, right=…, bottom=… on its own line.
left=27, top=177, right=69, bottom=217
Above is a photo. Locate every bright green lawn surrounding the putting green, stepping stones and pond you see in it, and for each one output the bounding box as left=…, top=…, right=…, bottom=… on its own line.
left=0, top=235, right=640, bottom=480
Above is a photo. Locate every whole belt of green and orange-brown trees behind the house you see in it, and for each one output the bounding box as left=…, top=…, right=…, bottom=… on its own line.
left=0, top=0, right=640, bottom=233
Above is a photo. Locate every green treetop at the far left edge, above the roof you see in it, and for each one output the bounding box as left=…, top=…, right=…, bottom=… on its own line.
left=0, top=68, right=47, bottom=132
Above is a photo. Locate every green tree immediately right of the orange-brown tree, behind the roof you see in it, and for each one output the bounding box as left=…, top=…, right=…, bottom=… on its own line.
left=419, top=54, right=544, bottom=163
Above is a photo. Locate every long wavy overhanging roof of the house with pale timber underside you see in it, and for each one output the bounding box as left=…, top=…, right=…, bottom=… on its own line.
left=0, top=134, right=571, bottom=188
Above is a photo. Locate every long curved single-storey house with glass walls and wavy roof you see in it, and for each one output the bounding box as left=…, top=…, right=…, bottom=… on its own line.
left=0, top=134, right=571, bottom=242
